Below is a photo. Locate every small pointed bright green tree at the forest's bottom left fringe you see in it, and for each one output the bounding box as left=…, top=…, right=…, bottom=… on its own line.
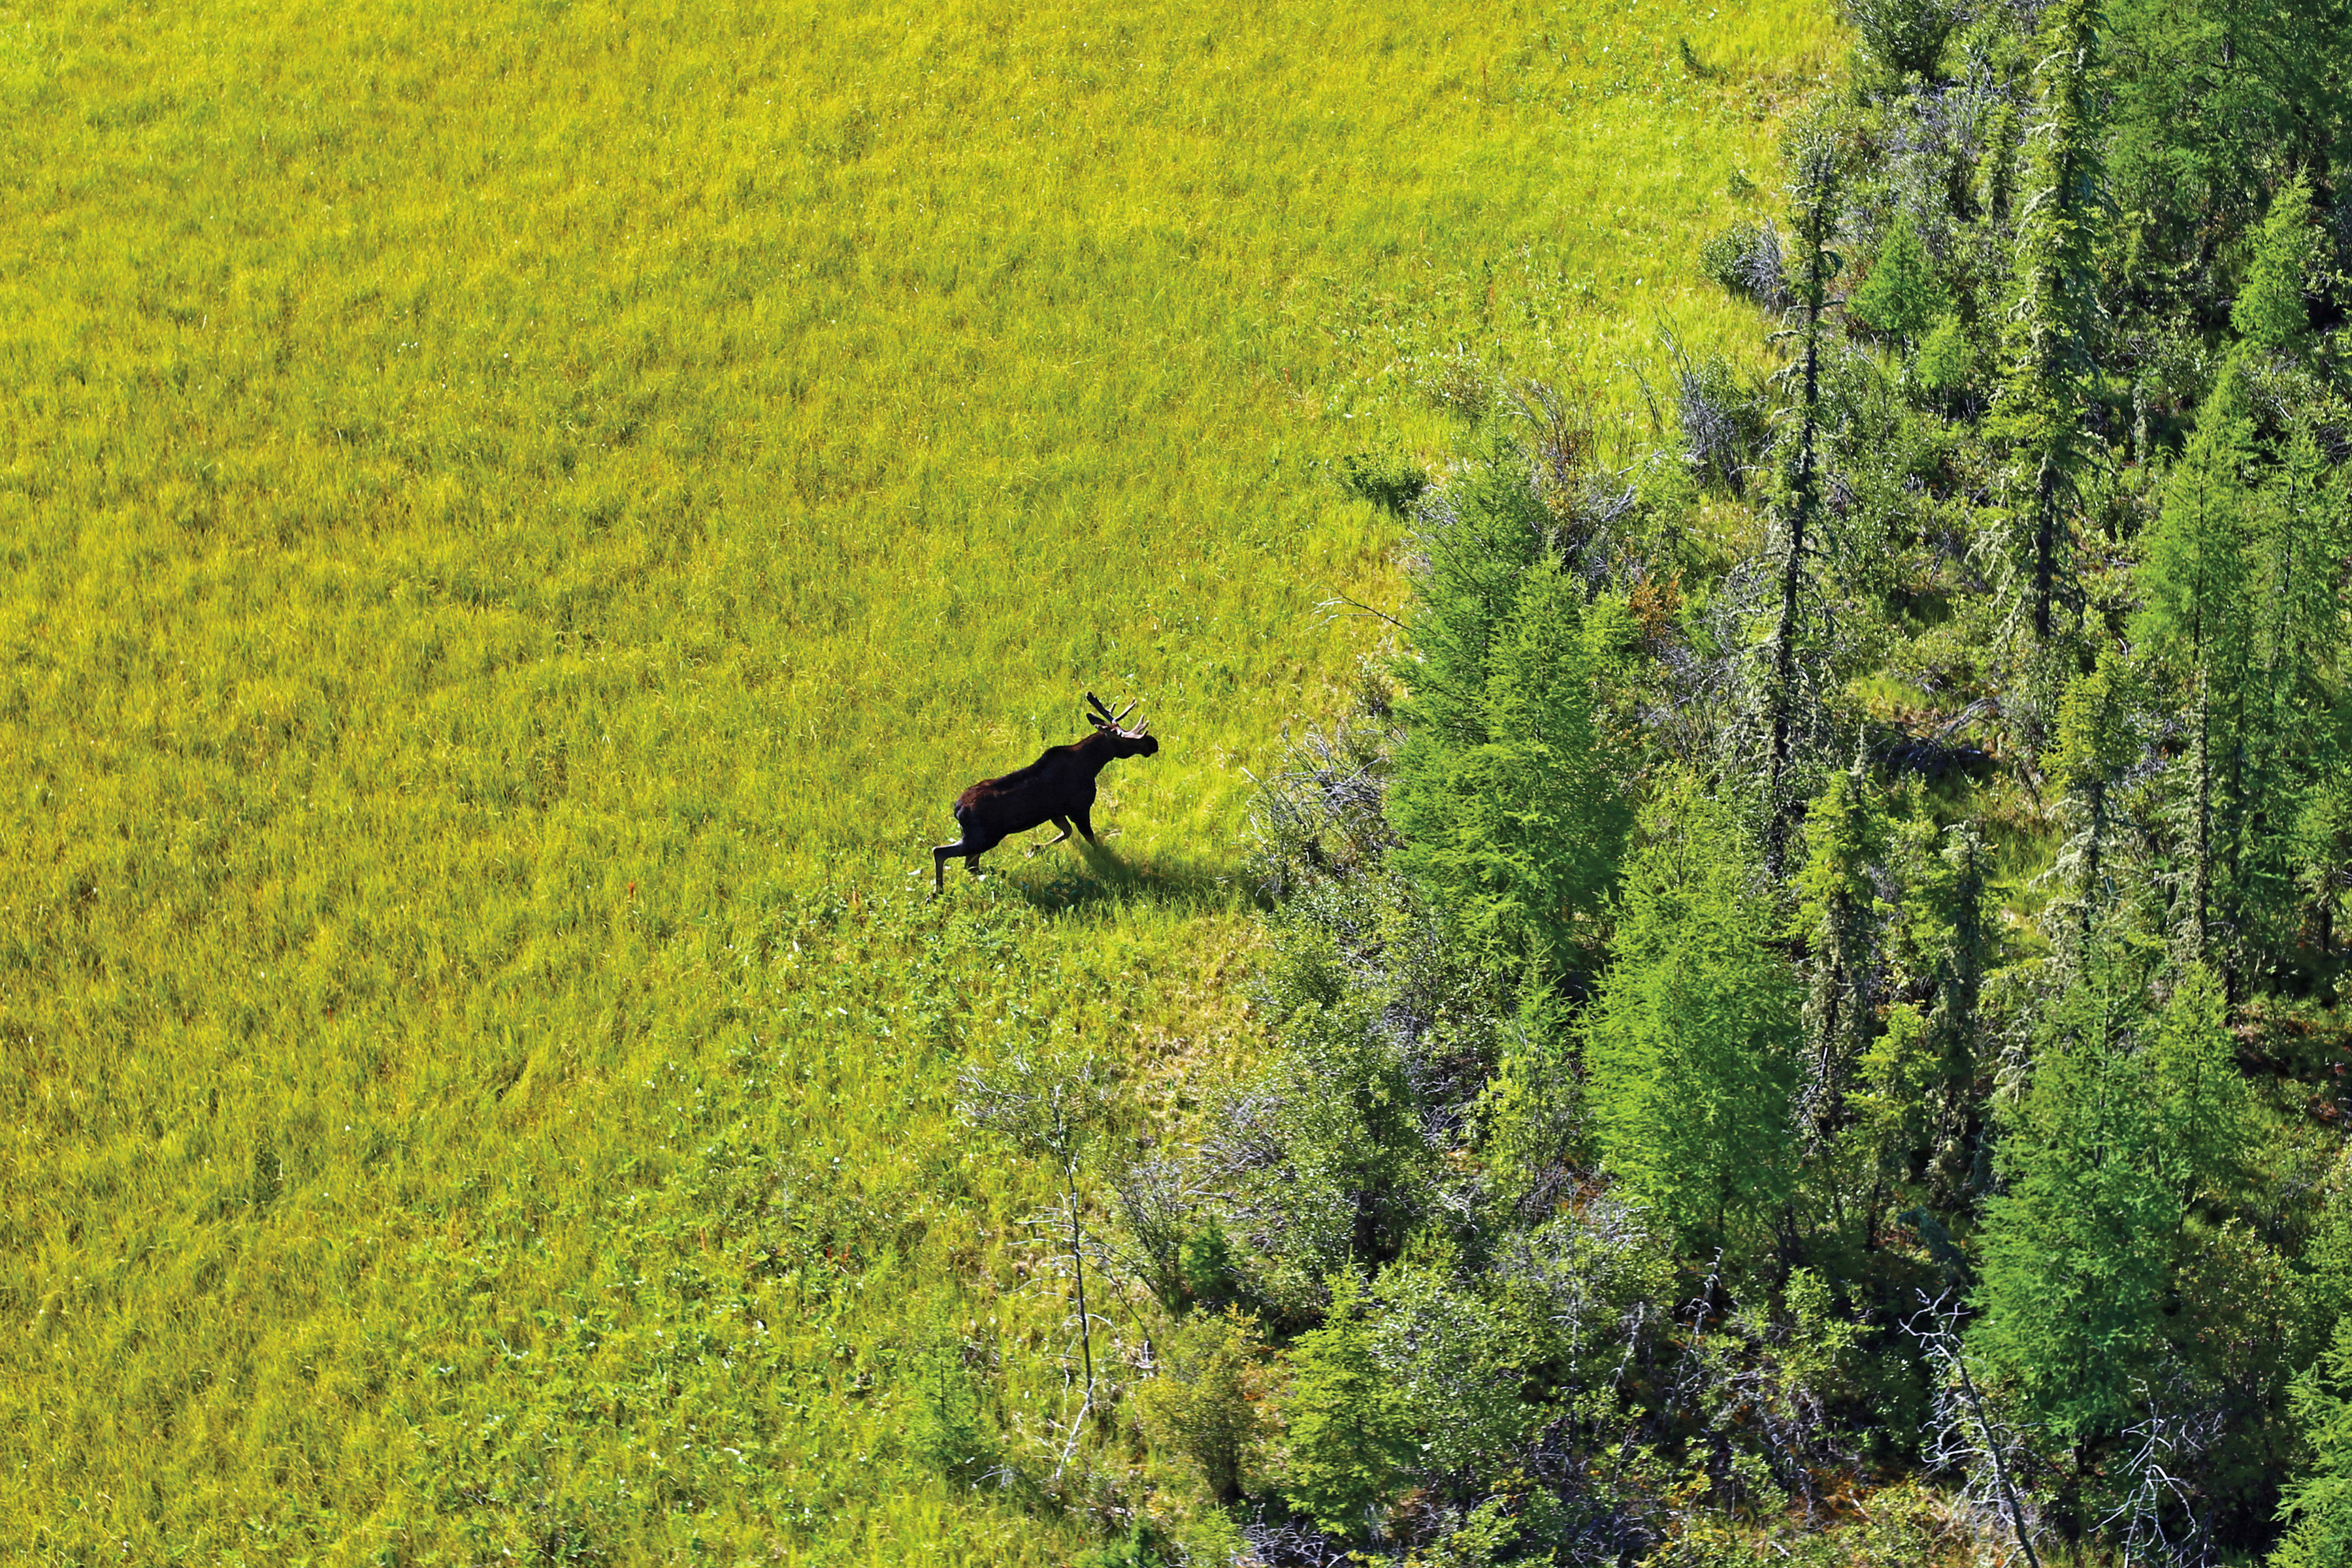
left=1282, top=1277, right=1418, bottom=1535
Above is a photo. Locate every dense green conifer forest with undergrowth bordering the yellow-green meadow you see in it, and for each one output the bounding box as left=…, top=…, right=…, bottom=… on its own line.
left=1138, top=0, right=2352, bottom=1568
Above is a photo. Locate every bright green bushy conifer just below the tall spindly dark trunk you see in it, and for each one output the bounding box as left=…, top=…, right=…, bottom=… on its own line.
left=1583, top=785, right=1802, bottom=1250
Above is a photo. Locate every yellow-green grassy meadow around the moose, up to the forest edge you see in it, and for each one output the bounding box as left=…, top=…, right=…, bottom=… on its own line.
left=0, top=0, right=1837, bottom=1563
